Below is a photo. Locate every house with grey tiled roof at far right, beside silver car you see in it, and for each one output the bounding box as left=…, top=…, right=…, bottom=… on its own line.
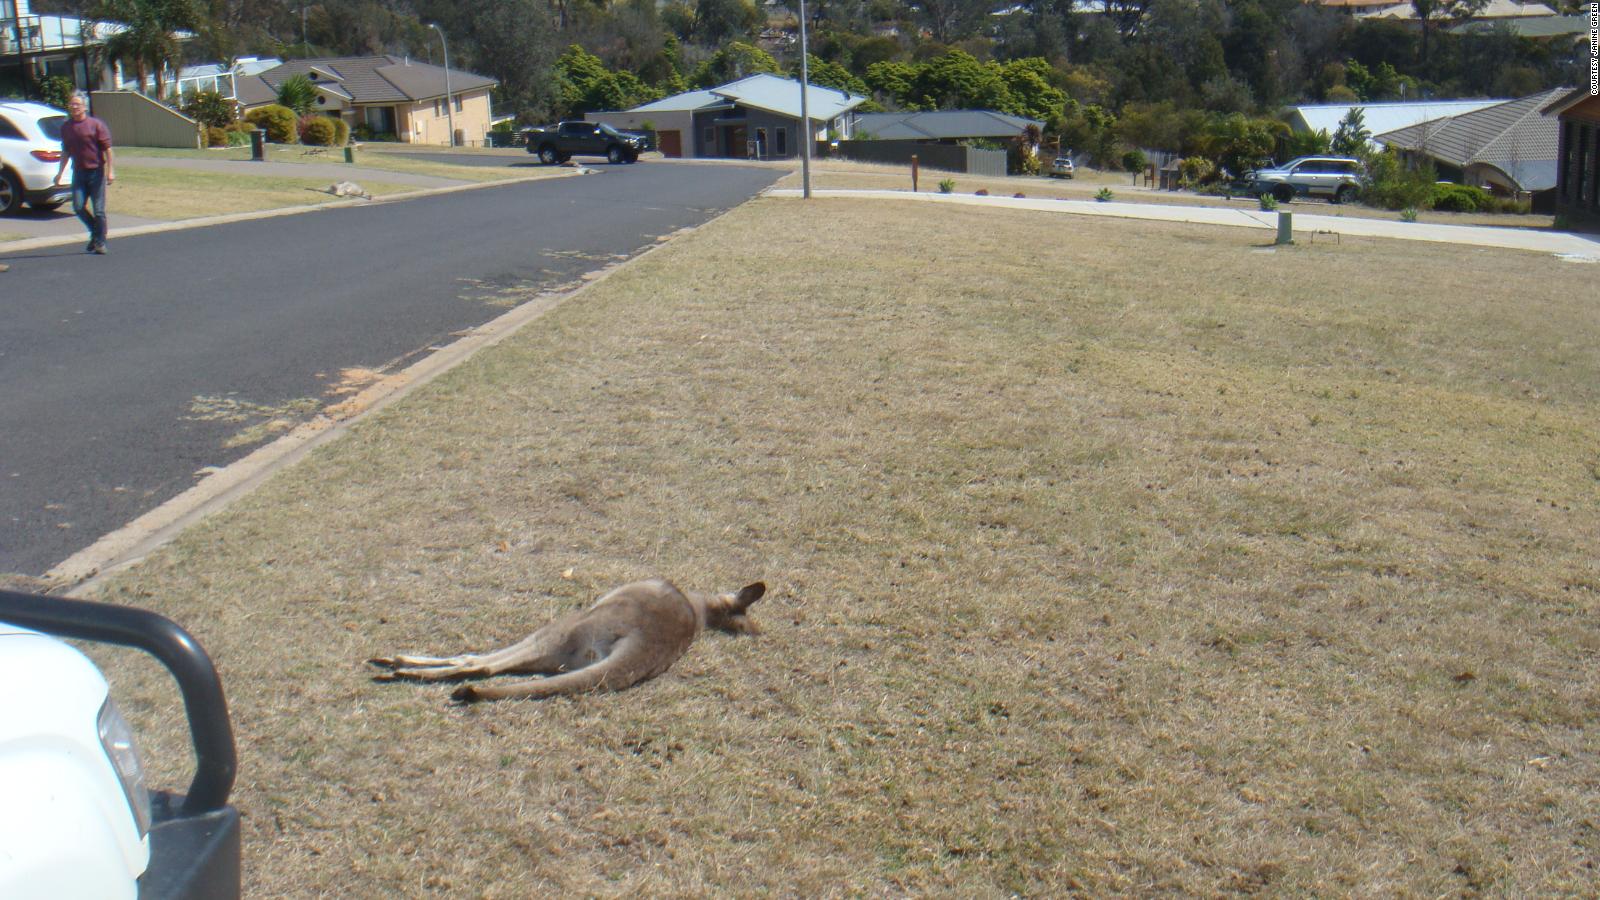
left=1376, top=88, right=1566, bottom=207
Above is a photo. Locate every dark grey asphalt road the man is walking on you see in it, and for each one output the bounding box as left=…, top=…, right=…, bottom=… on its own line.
left=0, top=163, right=782, bottom=575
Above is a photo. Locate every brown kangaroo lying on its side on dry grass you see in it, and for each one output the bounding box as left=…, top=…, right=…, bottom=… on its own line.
left=366, top=578, right=766, bottom=703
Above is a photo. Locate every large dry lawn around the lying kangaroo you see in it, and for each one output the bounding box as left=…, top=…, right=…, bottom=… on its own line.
left=84, top=200, right=1600, bottom=897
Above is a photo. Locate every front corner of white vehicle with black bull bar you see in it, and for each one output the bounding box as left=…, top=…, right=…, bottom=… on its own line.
left=0, top=591, right=240, bottom=900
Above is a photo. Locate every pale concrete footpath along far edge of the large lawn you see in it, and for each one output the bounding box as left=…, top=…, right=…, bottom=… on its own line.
left=766, top=189, right=1600, bottom=263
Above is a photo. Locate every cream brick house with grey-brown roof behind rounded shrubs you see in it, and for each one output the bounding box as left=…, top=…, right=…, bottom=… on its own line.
left=235, top=56, right=499, bottom=146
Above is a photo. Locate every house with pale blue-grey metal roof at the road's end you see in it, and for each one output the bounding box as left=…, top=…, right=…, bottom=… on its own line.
left=586, top=74, right=867, bottom=159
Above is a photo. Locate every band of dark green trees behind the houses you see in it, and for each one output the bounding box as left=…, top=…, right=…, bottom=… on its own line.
left=34, top=0, right=1586, bottom=155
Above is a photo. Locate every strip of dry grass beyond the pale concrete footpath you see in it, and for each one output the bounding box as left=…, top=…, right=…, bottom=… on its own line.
left=781, top=160, right=1555, bottom=229
